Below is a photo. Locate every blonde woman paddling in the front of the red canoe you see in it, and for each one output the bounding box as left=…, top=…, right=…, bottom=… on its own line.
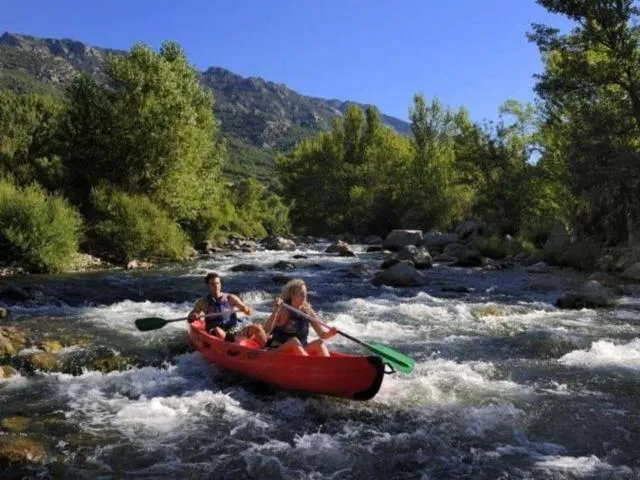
left=265, top=279, right=337, bottom=357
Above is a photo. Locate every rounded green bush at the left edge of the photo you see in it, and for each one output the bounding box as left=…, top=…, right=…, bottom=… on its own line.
left=0, top=179, right=82, bottom=272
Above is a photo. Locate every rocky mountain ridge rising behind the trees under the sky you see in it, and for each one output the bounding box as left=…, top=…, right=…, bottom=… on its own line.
left=0, top=32, right=410, bottom=178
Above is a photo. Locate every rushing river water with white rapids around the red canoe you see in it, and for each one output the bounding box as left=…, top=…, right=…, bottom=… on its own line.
left=0, top=244, right=640, bottom=479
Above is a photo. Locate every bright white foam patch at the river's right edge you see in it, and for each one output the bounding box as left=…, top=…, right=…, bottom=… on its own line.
left=558, top=338, right=640, bottom=371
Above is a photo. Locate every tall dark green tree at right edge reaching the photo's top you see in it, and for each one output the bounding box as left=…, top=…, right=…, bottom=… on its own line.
left=529, top=0, right=640, bottom=245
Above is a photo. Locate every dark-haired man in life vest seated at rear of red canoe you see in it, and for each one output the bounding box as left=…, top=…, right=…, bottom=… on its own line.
left=188, top=272, right=267, bottom=347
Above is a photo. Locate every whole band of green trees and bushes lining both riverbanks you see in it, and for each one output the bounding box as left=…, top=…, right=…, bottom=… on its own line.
left=0, top=0, right=640, bottom=272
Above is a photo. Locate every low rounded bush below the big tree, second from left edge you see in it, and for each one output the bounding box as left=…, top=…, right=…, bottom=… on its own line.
left=89, top=187, right=189, bottom=262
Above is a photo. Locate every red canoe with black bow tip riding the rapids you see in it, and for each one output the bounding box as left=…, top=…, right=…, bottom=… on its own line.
left=189, top=321, right=384, bottom=400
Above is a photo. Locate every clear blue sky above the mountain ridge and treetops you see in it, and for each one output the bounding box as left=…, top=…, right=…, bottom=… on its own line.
left=0, top=0, right=570, bottom=120
